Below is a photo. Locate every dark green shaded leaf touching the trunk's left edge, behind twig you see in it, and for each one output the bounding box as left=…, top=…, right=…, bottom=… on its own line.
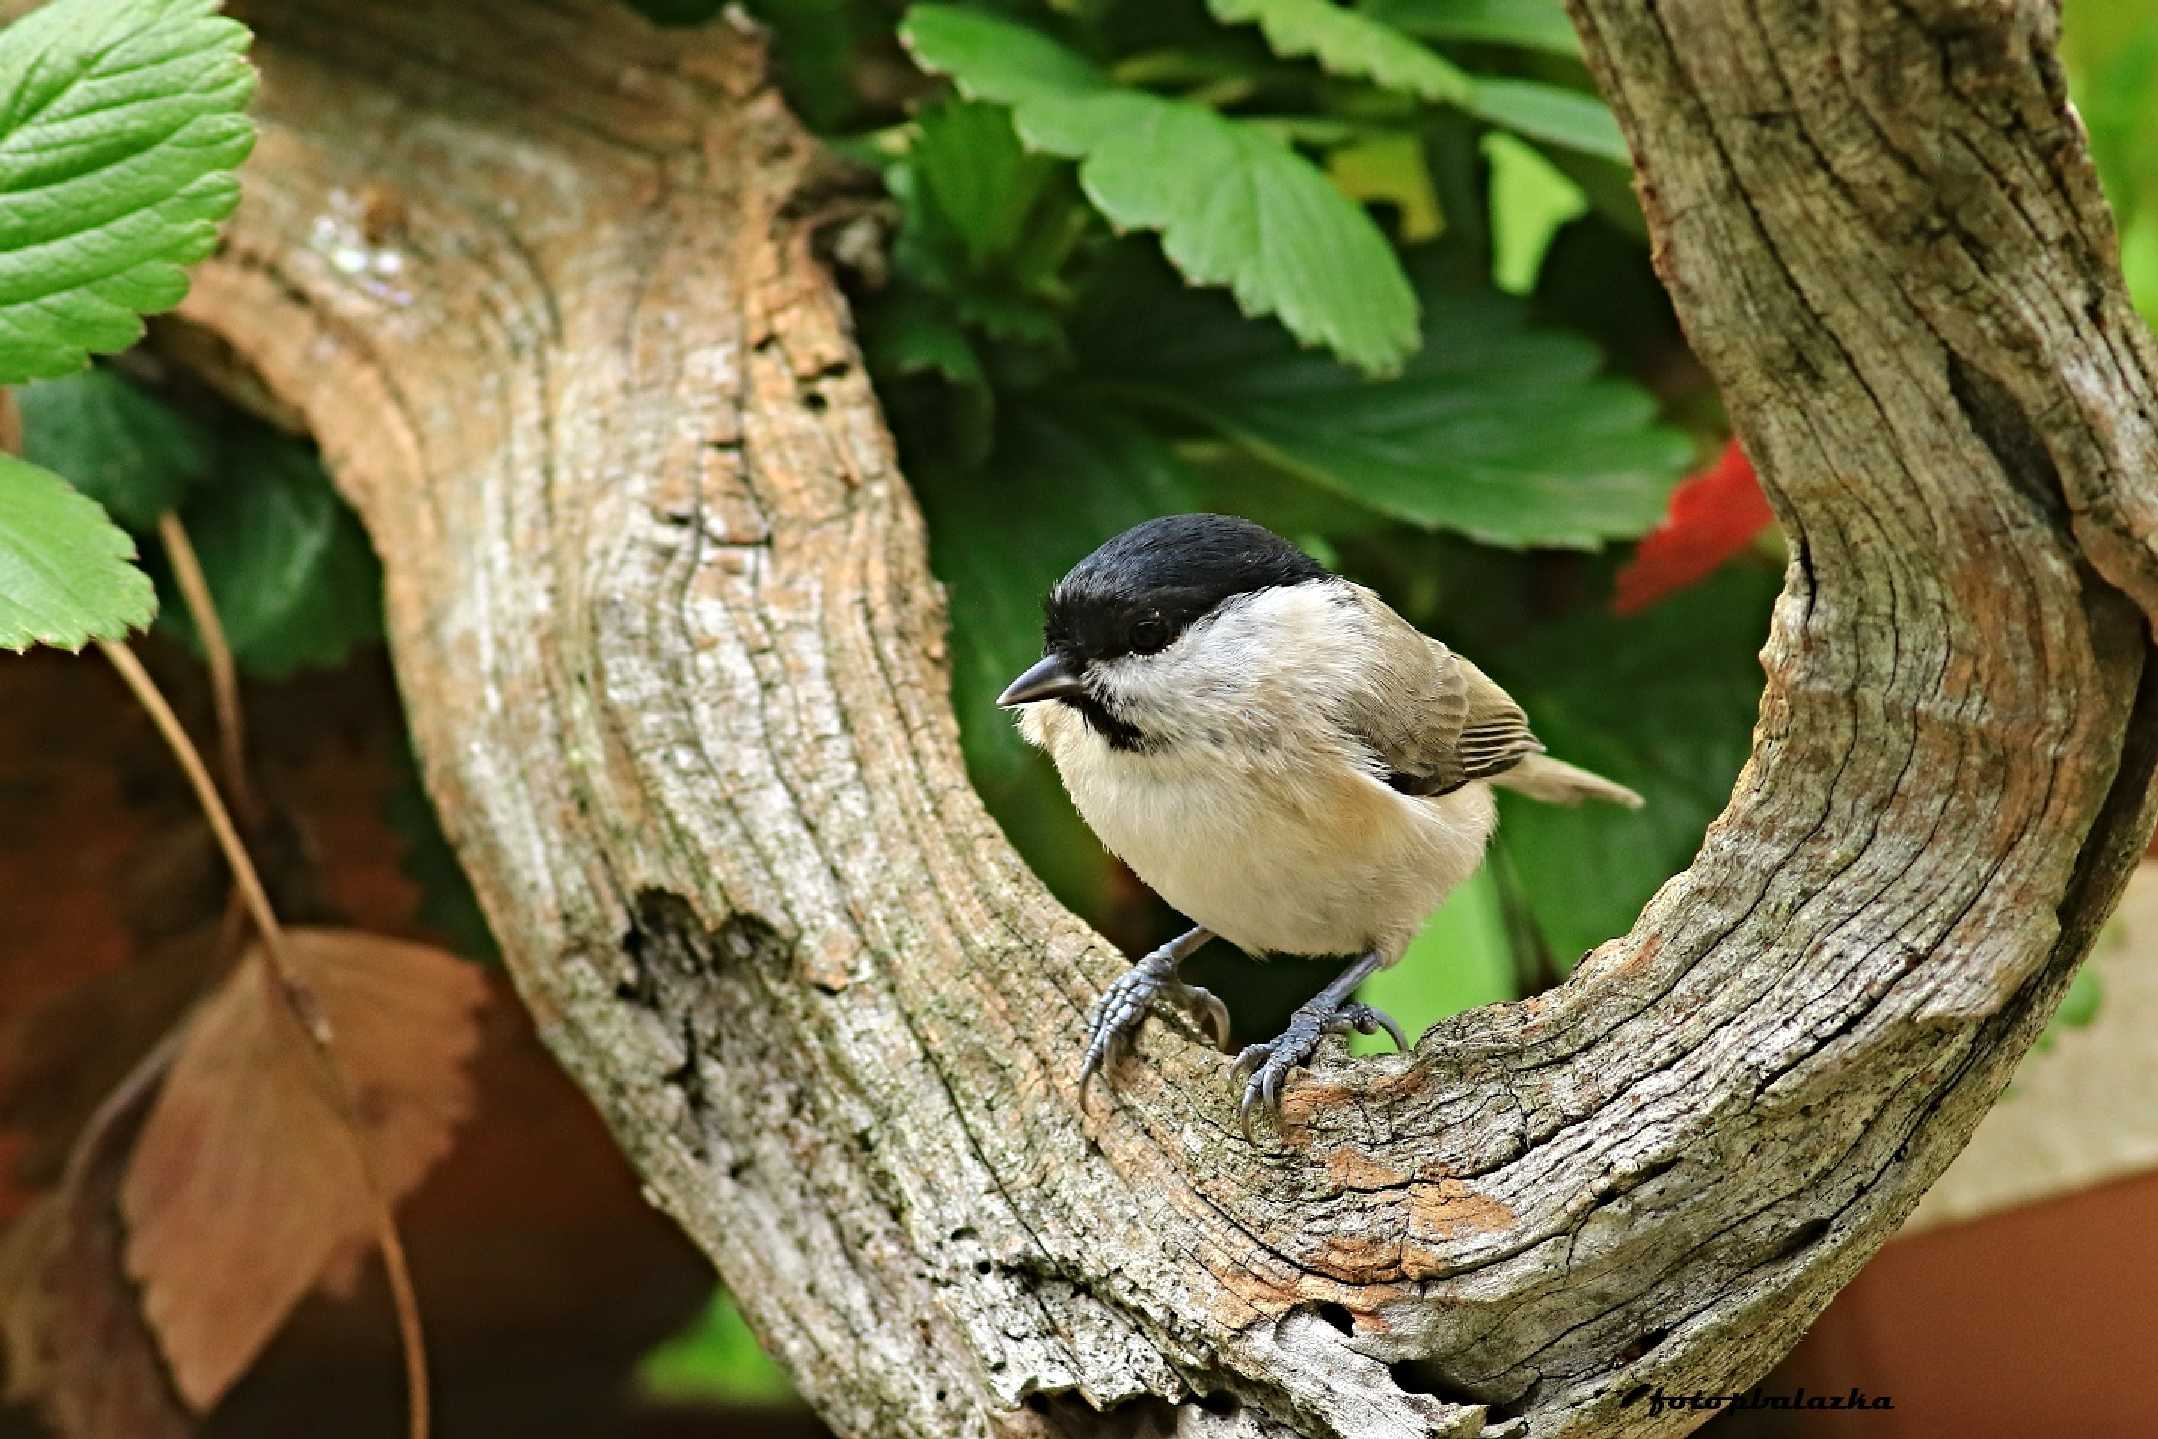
left=166, top=429, right=382, bottom=677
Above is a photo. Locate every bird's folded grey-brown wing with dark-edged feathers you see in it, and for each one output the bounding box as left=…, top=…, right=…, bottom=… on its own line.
left=1342, top=595, right=1543, bottom=794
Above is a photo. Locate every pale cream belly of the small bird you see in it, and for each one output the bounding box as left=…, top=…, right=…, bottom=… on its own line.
left=1049, top=707, right=1495, bottom=958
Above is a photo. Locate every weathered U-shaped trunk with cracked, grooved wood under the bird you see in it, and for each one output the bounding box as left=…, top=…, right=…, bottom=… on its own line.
left=143, top=0, right=2158, bottom=1439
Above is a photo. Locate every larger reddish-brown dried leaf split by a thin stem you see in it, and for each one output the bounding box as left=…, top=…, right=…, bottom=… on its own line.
left=121, top=930, right=488, bottom=1411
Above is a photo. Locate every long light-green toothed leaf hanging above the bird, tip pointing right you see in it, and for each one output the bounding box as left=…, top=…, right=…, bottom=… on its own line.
left=900, top=4, right=1416, bottom=373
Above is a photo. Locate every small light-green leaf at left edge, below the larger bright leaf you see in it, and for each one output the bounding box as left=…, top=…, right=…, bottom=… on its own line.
left=0, top=455, right=158, bottom=652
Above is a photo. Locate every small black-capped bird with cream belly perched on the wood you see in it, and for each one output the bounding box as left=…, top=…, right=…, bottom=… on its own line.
left=997, top=513, right=1642, bottom=1137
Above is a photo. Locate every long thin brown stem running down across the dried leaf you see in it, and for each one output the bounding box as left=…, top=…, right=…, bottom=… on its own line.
left=99, top=641, right=427, bottom=1439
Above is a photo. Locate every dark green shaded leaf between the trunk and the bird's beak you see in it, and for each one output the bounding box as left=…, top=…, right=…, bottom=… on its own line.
left=909, top=399, right=1193, bottom=915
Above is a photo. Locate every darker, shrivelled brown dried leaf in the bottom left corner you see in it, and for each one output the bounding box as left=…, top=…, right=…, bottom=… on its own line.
left=0, top=1044, right=194, bottom=1439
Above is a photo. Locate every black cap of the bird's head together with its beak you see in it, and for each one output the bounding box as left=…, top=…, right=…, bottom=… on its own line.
left=997, top=516, right=1329, bottom=710
